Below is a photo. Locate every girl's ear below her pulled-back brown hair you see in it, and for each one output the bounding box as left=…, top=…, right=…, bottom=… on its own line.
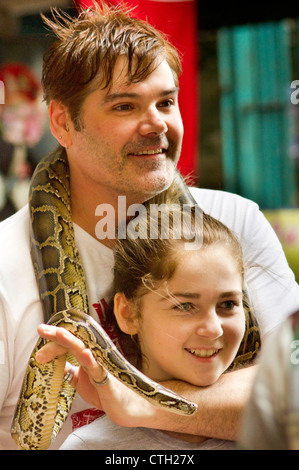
left=114, top=292, right=139, bottom=335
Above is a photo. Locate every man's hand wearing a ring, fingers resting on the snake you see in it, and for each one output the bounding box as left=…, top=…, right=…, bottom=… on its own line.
left=36, top=324, right=161, bottom=427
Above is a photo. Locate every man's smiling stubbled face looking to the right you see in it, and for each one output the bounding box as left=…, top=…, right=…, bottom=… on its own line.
left=68, top=58, right=183, bottom=203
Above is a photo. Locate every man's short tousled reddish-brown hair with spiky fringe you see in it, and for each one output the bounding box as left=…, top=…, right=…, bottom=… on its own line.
left=42, top=3, right=181, bottom=130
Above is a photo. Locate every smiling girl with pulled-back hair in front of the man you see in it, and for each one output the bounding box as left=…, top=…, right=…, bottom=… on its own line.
left=39, top=210, right=259, bottom=450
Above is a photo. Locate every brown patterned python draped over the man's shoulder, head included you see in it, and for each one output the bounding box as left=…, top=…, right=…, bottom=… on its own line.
left=11, top=149, right=197, bottom=450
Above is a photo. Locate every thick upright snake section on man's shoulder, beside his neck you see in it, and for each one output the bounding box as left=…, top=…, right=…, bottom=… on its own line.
left=29, top=149, right=88, bottom=321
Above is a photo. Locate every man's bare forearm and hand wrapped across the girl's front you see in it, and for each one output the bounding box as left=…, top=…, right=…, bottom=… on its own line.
left=37, top=325, right=256, bottom=440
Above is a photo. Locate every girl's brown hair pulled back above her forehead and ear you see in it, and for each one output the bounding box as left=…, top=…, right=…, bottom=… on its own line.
left=114, top=209, right=244, bottom=299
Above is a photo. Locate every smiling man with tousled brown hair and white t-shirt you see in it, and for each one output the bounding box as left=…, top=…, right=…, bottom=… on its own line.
left=0, top=3, right=299, bottom=448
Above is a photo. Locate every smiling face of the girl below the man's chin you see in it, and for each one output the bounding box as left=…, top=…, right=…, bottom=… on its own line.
left=130, top=246, right=245, bottom=386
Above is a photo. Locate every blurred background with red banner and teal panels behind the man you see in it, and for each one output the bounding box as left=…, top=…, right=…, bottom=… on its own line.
left=0, top=0, right=299, bottom=280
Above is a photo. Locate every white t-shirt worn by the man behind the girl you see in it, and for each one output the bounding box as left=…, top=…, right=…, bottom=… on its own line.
left=0, top=188, right=299, bottom=449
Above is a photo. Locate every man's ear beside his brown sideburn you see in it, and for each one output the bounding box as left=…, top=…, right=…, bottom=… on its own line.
left=49, top=100, right=72, bottom=148
